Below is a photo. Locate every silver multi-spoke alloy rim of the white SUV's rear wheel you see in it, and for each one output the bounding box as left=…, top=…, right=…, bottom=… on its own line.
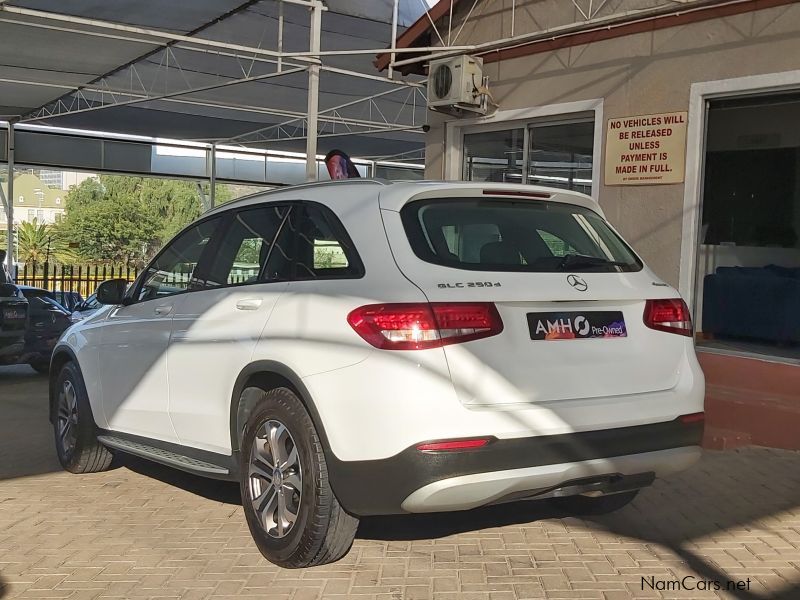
left=248, top=419, right=303, bottom=538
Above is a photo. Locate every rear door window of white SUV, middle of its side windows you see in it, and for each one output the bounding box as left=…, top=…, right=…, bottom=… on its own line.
left=205, top=205, right=287, bottom=287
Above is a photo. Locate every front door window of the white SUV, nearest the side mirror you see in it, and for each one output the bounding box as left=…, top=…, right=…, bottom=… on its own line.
left=137, top=217, right=221, bottom=302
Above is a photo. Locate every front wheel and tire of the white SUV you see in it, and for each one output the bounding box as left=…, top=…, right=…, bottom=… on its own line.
left=53, top=362, right=114, bottom=473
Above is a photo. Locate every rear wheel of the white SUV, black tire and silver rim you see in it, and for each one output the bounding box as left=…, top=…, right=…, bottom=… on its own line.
left=240, top=387, right=358, bottom=568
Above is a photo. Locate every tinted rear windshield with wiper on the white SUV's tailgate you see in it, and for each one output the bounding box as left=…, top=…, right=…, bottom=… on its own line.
left=400, top=198, right=642, bottom=273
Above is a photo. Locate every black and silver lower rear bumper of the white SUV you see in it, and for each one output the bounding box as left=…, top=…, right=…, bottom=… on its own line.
left=329, top=419, right=703, bottom=515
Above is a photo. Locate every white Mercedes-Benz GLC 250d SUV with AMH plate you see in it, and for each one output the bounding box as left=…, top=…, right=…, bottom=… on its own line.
left=50, top=180, right=704, bottom=567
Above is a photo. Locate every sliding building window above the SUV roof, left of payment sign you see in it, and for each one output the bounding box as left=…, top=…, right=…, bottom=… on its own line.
left=462, top=114, right=594, bottom=194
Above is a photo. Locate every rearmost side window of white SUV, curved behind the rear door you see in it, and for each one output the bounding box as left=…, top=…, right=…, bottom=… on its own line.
left=290, top=204, right=364, bottom=279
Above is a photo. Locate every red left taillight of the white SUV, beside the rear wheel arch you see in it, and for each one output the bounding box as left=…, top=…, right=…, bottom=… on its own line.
left=347, top=302, right=503, bottom=350
